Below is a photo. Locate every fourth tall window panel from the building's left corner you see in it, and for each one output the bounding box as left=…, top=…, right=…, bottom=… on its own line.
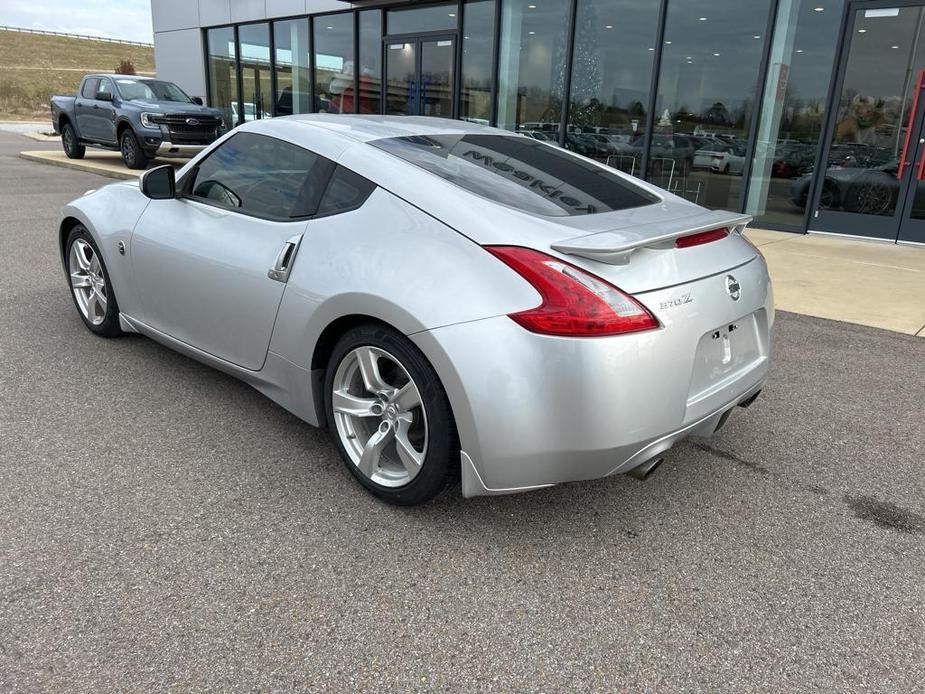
left=314, top=12, right=355, bottom=113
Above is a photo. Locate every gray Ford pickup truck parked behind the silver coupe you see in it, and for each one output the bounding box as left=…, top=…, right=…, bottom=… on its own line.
left=51, top=75, right=225, bottom=169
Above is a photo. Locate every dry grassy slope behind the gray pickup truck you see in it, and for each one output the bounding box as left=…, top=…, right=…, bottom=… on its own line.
left=0, top=30, right=154, bottom=120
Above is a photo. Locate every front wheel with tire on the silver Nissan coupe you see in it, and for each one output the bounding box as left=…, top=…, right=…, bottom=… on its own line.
left=64, top=224, right=122, bottom=337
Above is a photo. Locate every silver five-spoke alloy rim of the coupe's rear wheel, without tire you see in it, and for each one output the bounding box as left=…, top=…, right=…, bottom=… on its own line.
left=331, top=345, right=428, bottom=487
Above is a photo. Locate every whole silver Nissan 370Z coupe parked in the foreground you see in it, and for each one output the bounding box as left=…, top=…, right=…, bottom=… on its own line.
left=60, top=115, right=774, bottom=504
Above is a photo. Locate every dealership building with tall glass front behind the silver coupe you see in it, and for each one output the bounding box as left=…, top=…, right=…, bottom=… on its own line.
left=152, top=0, right=925, bottom=243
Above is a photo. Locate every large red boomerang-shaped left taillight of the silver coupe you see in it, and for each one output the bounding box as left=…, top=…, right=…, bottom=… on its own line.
left=485, top=246, right=659, bottom=337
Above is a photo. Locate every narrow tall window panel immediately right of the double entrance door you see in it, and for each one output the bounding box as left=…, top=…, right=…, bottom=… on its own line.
left=459, top=0, right=495, bottom=125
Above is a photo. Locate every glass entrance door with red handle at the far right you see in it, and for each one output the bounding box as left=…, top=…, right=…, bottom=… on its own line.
left=812, top=0, right=925, bottom=242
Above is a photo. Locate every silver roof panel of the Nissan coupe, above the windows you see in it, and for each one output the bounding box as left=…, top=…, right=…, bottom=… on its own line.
left=276, top=113, right=515, bottom=142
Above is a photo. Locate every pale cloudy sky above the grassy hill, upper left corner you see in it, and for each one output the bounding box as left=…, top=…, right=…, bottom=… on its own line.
left=0, top=0, right=153, bottom=43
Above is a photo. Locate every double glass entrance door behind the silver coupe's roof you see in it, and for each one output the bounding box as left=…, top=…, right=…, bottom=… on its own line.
left=385, top=36, right=456, bottom=118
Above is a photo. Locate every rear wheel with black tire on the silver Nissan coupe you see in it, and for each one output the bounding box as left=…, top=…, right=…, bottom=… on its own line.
left=324, top=323, right=460, bottom=506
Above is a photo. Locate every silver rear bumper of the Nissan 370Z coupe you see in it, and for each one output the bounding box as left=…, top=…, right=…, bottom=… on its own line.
left=412, top=259, right=773, bottom=496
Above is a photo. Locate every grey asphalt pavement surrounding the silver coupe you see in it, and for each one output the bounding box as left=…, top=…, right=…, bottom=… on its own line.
left=0, top=133, right=925, bottom=692
